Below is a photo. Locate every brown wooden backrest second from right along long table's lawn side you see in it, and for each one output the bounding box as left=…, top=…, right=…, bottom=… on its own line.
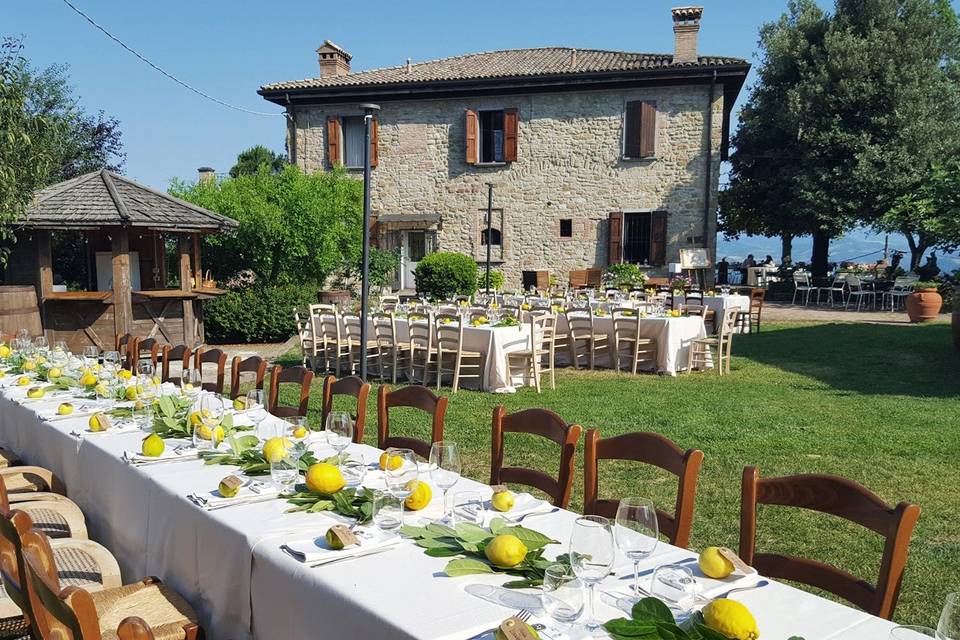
left=583, top=429, right=703, bottom=548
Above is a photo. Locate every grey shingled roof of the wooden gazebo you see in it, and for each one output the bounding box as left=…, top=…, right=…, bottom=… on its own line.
left=18, top=169, right=237, bottom=233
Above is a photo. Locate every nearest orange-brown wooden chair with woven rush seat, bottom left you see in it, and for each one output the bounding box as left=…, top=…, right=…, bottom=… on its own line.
left=22, top=529, right=203, bottom=640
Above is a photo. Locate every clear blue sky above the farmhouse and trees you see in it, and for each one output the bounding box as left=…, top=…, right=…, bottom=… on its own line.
left=7, top=0, right=960, bottom=270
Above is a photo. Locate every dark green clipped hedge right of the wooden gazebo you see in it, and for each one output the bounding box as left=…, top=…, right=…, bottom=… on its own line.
left=203, top=284, right=317, bottom=344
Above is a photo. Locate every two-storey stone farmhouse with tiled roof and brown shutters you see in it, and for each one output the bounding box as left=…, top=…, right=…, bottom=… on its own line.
left=259, top=7, right=750, bottom=289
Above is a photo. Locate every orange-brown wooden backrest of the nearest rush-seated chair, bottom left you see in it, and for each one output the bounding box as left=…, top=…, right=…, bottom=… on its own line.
left=22, top=529, right=101, bottom=640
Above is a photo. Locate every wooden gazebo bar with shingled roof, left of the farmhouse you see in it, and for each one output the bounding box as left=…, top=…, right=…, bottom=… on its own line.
left=5, top=169, right=237, bottom=351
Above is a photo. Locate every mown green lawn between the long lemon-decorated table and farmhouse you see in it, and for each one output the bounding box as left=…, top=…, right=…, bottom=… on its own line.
left=274, top=324, right=960, bottom=625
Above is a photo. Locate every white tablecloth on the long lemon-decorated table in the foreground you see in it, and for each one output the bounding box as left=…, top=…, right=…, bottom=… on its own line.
left=0, top=387, right=892, bottom=640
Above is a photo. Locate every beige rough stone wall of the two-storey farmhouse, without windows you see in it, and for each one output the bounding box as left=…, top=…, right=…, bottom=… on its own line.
left=295, top=85, right=723, bottom=288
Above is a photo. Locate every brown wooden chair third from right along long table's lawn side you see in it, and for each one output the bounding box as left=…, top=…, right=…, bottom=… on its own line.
left=490, top=405, right=583, bottom=509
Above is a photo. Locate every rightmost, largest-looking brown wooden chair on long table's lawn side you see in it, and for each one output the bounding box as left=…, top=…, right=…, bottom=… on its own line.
left=740, top=467, right=920, bottom=620
